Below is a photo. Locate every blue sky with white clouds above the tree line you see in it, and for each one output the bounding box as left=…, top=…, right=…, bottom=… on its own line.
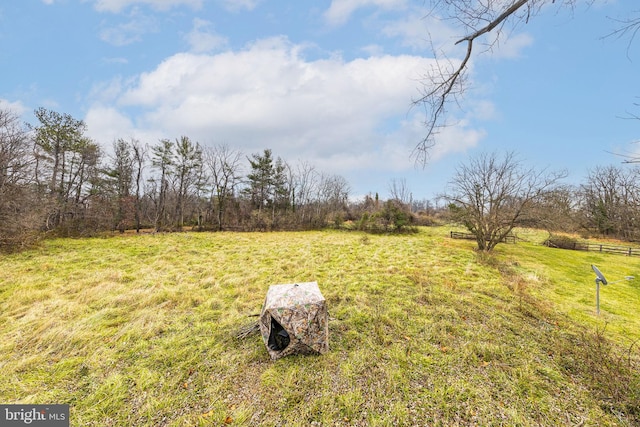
left=0, top=0, right=640, bottom=199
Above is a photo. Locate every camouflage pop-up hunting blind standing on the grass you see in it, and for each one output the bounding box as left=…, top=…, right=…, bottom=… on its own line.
left=260, top=282, right=329, bottom=360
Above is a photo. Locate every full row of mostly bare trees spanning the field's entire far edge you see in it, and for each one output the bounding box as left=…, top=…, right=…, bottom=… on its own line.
left=0, top=108, right=640, bottom=254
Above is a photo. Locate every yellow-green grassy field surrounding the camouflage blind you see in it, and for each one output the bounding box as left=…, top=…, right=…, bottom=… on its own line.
left=0, top=228, right=640, bottom=426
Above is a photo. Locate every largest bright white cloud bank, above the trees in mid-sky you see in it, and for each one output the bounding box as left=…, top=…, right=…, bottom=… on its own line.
left=86, top=38, right=482, bottom=173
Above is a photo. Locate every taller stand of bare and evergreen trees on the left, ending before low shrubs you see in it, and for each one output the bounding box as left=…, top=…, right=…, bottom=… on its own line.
left=0, top=108, right=350, bottom=248
